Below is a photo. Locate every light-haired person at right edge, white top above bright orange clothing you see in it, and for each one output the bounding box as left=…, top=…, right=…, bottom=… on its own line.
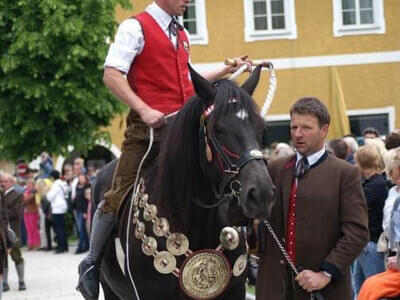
left=358, top=147, right=400, bottom=300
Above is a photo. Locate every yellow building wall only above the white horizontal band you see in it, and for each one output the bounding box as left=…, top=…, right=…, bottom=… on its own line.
left=116, top=0, right=400, bottom=59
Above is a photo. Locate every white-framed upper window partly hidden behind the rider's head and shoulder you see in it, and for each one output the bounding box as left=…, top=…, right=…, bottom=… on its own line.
left=180, top=0, right=208, bottom=45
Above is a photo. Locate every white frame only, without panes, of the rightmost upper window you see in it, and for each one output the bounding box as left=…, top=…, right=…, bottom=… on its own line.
left=332, top=0, right=386, bottom=37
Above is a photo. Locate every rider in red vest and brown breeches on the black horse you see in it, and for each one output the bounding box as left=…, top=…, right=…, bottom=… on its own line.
left=78, top=0, right=250, bottom=299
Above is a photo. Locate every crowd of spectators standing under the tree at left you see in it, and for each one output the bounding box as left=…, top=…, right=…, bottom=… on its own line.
left=0, top=153, right=97, bottom=299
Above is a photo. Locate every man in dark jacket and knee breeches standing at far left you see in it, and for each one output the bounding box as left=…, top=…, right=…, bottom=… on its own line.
left=0, top=173, right=26, bottom=292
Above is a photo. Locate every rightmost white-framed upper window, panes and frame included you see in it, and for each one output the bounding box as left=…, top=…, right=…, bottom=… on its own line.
left=332, top=0, right=386, bottom=36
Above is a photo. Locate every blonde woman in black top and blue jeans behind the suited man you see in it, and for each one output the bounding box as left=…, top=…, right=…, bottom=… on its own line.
left=353, top=145, right=388, bottom=295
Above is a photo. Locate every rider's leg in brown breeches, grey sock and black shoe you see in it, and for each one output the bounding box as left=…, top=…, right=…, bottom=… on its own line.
left=78, top=114, right=158, bottom=300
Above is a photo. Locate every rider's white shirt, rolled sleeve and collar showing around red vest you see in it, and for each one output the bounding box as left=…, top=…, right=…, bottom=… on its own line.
left=104, top=2, right=189, bottom=74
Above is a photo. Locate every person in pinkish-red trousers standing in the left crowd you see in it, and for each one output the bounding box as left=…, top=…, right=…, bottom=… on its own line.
left=24, top=179, right=40, bottom=250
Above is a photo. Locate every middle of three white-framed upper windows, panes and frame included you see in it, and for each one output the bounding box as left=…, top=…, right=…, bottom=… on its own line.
left=244, top=0, right=297, bottom=42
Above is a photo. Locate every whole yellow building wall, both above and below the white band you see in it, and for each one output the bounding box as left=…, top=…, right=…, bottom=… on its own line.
left=104, top=0, right=400, bottom=146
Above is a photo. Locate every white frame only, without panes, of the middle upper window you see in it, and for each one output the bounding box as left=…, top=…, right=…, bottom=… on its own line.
left=243, top=0, right=297, bottom=42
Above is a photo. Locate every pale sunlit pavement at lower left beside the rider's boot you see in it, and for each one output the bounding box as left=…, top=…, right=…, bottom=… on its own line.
left=2, top=246, right=104, bottom=300
